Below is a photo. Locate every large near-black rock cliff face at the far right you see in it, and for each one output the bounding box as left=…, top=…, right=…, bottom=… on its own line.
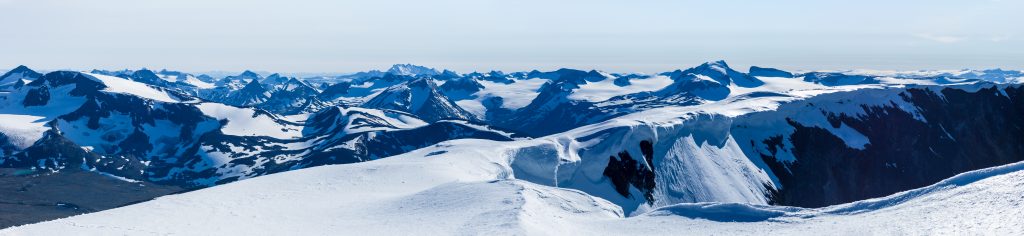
left=762, top=86, right=1024, bottom=207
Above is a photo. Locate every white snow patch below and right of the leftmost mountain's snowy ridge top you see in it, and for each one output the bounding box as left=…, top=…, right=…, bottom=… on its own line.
left=196, top=103, right=302, bottom=140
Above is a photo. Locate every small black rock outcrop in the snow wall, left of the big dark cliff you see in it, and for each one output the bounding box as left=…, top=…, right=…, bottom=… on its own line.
left=603, top=141, right=654, bottom=204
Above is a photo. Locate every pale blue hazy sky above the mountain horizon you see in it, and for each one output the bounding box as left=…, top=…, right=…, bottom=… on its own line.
left=0, top=0, right=1024, bottom=73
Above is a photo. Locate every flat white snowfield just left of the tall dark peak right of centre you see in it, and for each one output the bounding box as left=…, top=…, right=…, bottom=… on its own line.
left=568, top=76, right=673, bottom=103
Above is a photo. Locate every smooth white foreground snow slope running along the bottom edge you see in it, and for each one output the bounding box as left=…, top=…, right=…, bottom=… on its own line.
left=9, top=144, right=1024, bottom=235
